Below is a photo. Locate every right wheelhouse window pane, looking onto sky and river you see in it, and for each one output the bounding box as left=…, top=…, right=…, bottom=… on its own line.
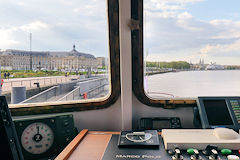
left=143, top=0, right=240, bottom=99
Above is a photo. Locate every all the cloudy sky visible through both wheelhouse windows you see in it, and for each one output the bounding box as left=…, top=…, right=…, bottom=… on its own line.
left=0, top=0, right=240, bottom=65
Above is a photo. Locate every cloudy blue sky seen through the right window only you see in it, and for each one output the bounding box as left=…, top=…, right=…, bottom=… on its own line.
left=144, top=0, right=240, bottom=65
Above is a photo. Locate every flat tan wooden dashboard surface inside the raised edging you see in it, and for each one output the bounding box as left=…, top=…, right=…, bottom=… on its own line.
left=68, top=132, right=112, bottom=160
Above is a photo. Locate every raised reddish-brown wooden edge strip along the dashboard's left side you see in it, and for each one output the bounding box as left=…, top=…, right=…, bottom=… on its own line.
left=55, top=129, right=88, bottom=160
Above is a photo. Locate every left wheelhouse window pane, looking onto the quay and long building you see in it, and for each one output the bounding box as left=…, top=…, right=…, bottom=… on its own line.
left=0, top=0, right=112, bottom=106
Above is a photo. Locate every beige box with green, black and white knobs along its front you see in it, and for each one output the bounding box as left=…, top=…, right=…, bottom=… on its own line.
left=161, top=128, right=240, bottom=160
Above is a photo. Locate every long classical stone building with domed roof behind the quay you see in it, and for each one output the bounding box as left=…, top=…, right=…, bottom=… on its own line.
left=0, top=45, right=98, bottom=71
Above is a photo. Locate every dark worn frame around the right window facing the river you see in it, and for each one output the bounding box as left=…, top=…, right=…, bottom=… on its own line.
left=131, top=0, right=197, bottom=108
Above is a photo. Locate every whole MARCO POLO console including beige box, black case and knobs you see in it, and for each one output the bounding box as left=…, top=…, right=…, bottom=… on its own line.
left=102, top=128, right=240, bottom=160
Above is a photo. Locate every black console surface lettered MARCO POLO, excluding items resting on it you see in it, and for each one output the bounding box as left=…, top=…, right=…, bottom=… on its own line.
left=102, top=135, right=240, bottom=160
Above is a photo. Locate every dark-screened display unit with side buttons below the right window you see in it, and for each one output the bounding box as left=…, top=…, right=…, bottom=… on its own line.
left=197, top=97, right=240, bottom=131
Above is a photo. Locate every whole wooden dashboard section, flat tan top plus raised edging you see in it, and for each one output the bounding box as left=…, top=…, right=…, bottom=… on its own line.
left=55, top=129, right=120, bottom=160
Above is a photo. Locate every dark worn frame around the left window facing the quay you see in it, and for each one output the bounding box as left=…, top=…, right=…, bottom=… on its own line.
left=9, top=0, right=120, bottom=116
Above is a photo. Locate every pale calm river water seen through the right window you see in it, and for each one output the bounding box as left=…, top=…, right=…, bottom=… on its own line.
left=144, top=70, right=240, bottom=98
